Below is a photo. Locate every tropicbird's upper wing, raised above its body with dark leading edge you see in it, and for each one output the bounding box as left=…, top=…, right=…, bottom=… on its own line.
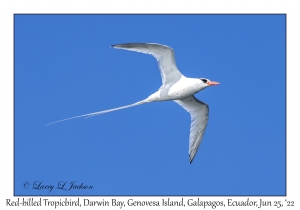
left=111, top=43, right=182, bottom=86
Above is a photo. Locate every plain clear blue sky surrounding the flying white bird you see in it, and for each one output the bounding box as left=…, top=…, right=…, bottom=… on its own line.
left=14, top=15, right=286, bottom=195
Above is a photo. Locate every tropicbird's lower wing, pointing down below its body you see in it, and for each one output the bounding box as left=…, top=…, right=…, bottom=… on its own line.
left=174, top=96, right=208, bottom=163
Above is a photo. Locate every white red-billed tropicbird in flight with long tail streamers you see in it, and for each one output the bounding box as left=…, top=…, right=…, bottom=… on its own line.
left=47, top=43, right=220, bottom=163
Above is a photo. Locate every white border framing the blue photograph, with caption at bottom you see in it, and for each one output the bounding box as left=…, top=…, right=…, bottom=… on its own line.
left=0, top=0, right=300, bottom=209
